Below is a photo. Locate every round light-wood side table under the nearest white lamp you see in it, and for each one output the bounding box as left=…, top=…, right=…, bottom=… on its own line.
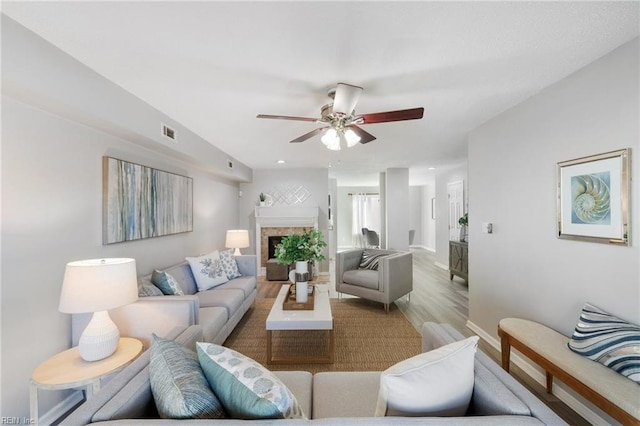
left=29, top=337, right=142, bottom=424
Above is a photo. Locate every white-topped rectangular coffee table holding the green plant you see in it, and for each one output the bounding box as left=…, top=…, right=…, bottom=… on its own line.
left=266, top=284, right=334, bottom=364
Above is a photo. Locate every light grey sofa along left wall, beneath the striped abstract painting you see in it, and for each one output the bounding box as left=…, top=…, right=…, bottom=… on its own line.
left=72, top=255, right=258, bottom=348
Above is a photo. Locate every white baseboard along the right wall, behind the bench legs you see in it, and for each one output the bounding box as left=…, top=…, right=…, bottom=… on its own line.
left=465, top=320, right=611, bottom=425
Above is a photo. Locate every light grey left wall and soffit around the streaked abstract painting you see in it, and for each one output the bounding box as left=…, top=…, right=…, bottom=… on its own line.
left=0, top=17, right=244, bottom=418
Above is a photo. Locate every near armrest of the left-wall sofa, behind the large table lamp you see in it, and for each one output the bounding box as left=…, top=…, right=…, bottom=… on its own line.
left=71, top=295, right=199, bottom=348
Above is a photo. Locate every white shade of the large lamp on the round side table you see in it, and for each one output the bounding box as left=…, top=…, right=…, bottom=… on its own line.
left=58, top=258, right=138, bottom=314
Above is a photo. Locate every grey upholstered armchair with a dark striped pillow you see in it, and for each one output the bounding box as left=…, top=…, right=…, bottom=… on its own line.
left=336, top=249, right=413, bottom=312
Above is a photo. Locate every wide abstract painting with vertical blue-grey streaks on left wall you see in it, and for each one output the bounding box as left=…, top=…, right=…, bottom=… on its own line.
left=102, top=157, right=193, bottom=244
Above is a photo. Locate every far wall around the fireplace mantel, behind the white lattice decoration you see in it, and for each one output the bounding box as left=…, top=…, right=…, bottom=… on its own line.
left=239, top=169, right=329, bottom=272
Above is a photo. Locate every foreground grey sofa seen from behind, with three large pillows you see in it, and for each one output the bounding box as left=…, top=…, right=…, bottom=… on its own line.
left=61, top=323, right=566, bottom=426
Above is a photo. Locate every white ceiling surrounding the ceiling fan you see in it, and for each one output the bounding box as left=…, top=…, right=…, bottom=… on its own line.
left=2, top=1, right=639, bottom=186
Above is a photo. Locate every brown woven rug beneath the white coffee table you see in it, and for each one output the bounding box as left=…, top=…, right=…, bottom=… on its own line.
left=224, top=298, right=421, bottom=373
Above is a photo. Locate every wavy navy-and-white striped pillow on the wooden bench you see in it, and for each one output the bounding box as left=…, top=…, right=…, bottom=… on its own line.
left=568, top=303, right=640, bottom=383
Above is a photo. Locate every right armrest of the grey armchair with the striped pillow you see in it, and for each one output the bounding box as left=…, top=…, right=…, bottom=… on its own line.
left=378, top=252, right=413, bottom=301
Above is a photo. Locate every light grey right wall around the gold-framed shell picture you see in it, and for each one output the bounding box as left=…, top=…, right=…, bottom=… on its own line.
left=469, top=38, right=640, bottom=423
